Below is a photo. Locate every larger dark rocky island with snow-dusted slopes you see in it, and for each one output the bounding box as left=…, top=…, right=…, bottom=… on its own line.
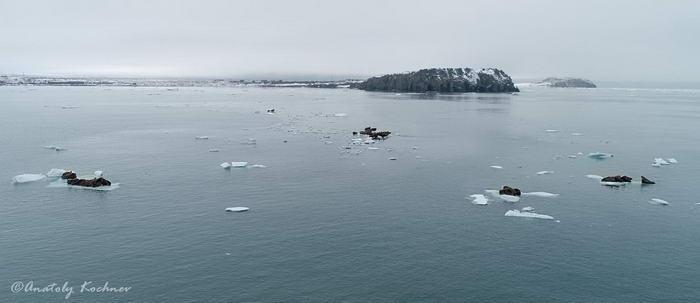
left=352, top=68, right=519, bottom=93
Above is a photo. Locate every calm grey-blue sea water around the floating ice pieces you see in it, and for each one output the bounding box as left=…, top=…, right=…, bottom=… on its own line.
left=0, top=87, right=700, bottom=302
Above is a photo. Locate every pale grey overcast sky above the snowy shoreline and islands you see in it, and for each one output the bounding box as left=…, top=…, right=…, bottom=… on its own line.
left=0, top=0, right=700, bottom=81
